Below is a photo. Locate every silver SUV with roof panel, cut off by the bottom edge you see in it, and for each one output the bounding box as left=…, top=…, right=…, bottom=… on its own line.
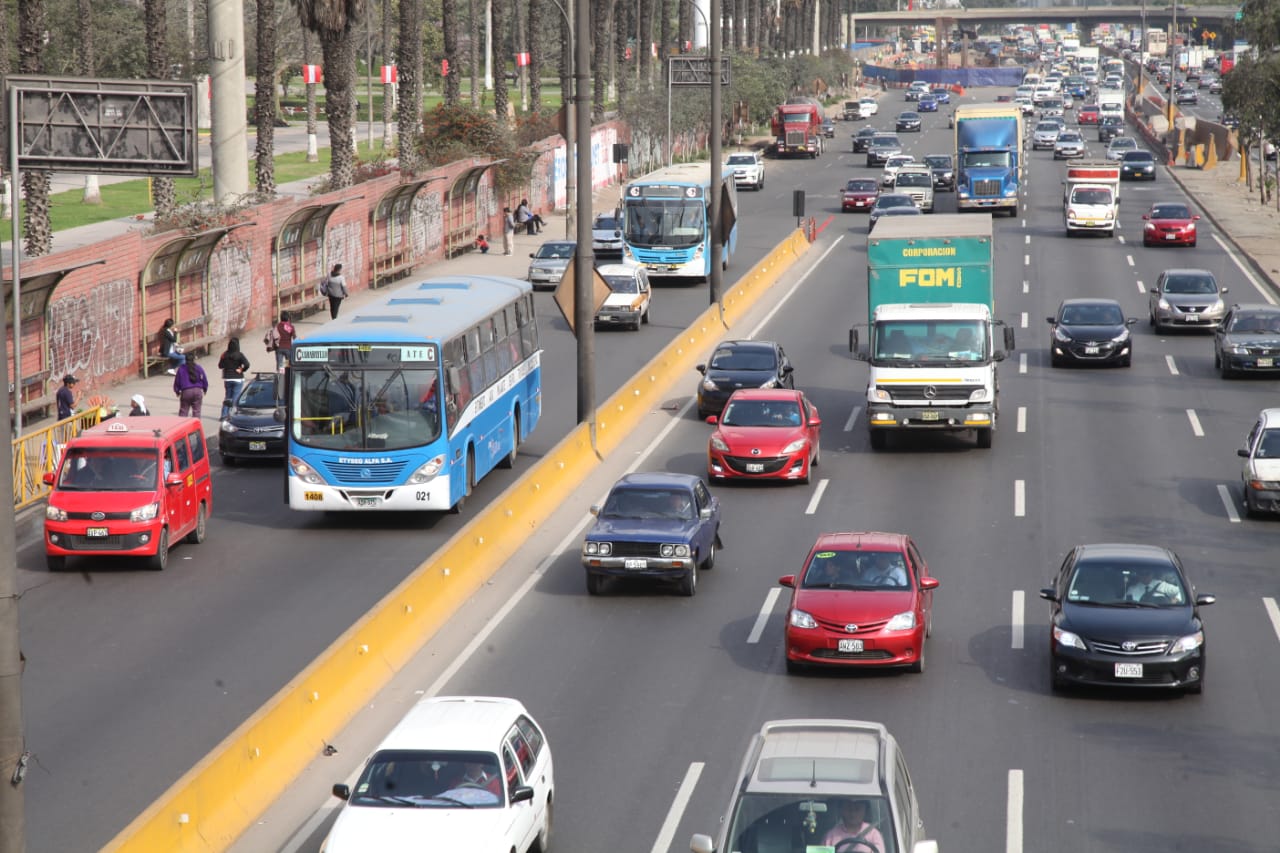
left=689, top=720, right=938, bottom=853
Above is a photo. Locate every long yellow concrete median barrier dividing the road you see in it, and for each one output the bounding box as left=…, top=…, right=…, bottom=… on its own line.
left=102, top=229, right=809, bottom=853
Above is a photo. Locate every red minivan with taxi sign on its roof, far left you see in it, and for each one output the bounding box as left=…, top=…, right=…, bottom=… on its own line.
left=45, top=416, right=214, bottom=571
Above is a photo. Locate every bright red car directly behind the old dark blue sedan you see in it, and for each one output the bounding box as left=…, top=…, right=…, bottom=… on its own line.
left=707, top=388, right=822, bottom=483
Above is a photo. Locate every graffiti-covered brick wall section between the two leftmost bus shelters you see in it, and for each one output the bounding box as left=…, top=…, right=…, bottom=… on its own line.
left=49, top=278, right=138, bottom=379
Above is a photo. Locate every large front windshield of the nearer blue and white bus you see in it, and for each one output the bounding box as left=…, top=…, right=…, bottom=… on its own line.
left=292, top=364, right=442, bottom=451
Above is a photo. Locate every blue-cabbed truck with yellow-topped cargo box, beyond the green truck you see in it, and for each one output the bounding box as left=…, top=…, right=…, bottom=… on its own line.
left=955, top=104, right=1023, bottom=216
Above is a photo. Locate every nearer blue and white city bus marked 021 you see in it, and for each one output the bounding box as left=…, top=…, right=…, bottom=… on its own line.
left=285, top=275, right=541, bottom=511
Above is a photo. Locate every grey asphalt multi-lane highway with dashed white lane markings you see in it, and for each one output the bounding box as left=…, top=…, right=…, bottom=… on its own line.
left=20, top=92, right=1280, bottom=853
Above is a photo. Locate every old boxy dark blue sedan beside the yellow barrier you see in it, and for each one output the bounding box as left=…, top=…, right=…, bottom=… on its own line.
left=582, top=471, right=721, bottom=596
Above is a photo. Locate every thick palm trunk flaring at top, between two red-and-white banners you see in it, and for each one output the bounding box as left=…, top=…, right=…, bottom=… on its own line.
left=293, top=0, right=365, bottom=190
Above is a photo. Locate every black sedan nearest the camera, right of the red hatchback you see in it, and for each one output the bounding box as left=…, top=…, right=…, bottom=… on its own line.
left=1039, top=544, right=1216, bottom=693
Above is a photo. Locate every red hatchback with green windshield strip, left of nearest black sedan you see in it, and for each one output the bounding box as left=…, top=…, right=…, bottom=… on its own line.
left=778, top=533, right=938, bottom=672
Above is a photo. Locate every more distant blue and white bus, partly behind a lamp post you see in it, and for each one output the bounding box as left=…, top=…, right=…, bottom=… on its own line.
left=622, top=163, right=737, bottom=279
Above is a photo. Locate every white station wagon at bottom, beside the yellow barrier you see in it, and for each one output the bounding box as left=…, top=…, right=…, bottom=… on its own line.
left=320, top=697, right=554, bottom=853
